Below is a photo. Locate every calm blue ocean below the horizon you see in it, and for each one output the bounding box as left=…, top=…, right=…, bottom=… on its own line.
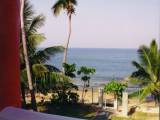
left=47, top=48, right=138, bottom=86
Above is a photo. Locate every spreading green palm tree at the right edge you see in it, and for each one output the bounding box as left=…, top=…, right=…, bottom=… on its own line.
left=131, top=40, right=160, bottom=116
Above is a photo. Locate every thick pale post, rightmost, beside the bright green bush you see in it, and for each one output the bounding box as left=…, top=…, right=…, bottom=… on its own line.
left=122, top=92, right=128, bottom=116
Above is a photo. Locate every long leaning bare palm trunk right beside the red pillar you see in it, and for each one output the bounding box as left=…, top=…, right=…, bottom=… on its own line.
left=20, top=0, right=37, bottom=111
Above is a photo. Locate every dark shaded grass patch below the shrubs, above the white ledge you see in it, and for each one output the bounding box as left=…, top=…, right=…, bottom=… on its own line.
left=38, top=104, right=97, bottom=119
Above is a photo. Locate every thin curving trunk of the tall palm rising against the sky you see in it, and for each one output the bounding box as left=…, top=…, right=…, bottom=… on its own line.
left=63, top=14, right=72, bottom=64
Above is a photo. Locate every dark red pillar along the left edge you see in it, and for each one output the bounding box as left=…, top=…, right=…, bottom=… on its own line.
left=0, top=0, right=21, bottom=110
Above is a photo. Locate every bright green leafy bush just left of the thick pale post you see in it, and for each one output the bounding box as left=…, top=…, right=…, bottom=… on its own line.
left=104, top=80, right=127, bottom=98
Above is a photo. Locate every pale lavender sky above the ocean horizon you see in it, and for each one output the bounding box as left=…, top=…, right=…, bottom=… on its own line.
left=30, top=0, right=160, bottom=48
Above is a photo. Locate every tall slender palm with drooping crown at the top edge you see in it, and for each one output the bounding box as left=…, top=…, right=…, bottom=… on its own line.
left=52, top=0, right=77, bottom=63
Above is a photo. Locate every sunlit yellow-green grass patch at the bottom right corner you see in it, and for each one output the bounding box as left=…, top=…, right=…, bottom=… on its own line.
left=111, top=112, right=159, bottom=120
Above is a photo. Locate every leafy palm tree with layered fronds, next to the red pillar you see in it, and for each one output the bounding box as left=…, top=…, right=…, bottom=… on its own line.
left=20, top=0, right=63, bottom=106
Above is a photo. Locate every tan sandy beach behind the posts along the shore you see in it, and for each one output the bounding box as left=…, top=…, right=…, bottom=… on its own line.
left=26, top=87, right=158, bottom=113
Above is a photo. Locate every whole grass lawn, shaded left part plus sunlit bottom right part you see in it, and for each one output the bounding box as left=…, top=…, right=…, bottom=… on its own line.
left=25, top=103, right=159, bottom=120
